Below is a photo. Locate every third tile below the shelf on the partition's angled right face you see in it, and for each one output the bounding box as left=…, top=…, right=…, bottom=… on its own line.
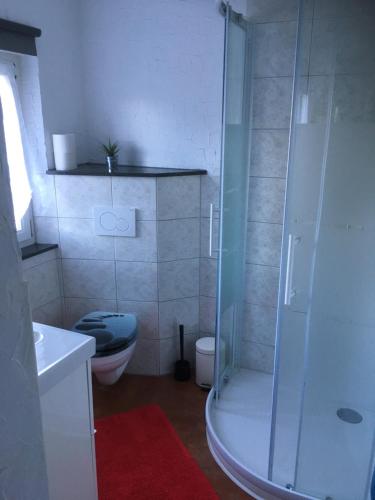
left=158, top=259, right=199, bottom=301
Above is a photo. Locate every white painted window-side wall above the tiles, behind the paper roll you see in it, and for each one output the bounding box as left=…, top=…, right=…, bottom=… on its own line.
left=0, top=0, right=86, bottom=166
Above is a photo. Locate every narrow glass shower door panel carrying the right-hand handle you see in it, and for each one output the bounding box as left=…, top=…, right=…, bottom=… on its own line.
left=269, top=2, right=326, bottom=488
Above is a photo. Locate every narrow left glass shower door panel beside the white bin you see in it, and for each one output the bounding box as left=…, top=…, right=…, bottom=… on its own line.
left=215, top=4, right=251, bottom=397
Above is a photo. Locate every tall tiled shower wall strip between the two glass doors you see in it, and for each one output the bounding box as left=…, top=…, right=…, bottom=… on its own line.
left=241, top=0, right=302, bottom=372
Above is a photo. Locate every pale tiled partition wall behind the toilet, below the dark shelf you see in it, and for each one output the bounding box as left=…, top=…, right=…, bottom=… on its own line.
left=33, top=176, right=201, bottom=375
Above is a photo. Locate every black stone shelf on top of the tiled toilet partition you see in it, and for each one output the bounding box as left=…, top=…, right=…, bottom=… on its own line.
left=46, top=163, right=207, bottom=177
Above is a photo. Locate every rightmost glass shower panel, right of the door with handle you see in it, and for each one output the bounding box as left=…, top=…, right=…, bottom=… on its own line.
left=296, top=8, right=375, bottom=500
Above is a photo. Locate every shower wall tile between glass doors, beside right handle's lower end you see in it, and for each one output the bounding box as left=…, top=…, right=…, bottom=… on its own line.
left=246, top=264, right=280, bottom=307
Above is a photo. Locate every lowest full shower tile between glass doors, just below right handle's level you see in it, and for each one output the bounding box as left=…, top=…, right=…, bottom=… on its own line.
left=242, top=304, right=277, bottom=346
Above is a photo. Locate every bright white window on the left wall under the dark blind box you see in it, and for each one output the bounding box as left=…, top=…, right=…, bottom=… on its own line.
left=0, top=57, right=32, bottom=246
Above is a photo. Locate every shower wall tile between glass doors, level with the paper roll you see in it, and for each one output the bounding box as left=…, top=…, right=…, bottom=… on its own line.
left=250, top=130, right=289, bottom=178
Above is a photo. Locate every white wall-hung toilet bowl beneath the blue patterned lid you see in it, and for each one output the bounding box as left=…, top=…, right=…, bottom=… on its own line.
left=91, top=342, right=137, bottom=385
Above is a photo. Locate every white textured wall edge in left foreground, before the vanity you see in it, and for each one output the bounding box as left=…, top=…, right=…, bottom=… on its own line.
left=0, top=104, right=48, bottom=500
